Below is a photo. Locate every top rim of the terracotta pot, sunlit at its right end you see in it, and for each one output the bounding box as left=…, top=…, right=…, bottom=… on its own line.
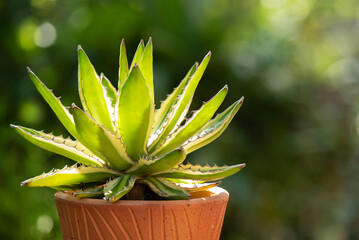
left=55, top=187, right=229, bottom=206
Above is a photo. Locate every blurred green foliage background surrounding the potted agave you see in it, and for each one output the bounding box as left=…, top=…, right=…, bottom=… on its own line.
left=0, top=0, right=359, bottom=240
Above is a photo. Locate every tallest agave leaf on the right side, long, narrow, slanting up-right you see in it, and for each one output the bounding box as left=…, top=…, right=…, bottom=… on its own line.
left=149, top=52, right=211, bottom=153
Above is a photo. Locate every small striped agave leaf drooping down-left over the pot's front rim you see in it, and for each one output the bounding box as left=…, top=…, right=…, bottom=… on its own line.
left=104, top=174, right=136, bottom=202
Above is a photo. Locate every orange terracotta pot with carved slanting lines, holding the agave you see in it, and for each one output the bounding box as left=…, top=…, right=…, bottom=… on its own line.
left=55, top=187, right=229, bottom=240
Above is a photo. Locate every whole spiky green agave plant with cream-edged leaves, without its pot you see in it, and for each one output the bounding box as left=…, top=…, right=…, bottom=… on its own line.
left=11, top=38, right=245, bottom=202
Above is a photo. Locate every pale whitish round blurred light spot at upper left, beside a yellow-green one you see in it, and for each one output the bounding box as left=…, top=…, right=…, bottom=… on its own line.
left=34, top=22, right=57, bottom=48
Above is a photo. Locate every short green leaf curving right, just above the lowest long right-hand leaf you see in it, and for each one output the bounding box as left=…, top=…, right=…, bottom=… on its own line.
left=126, top=149, right=186, bottom=176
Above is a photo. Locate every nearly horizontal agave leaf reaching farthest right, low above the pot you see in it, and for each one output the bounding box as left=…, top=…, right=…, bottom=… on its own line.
left=152, top=163, right=246, bottom=181
